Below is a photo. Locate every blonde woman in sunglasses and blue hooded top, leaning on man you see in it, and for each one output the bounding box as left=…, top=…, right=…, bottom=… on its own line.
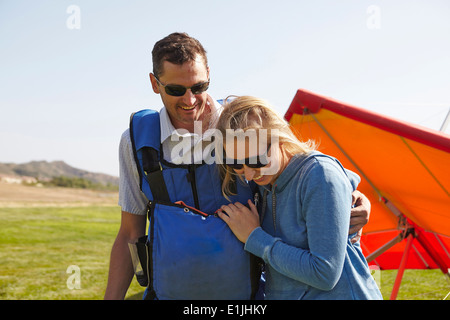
left=217, top=97, right=382, bottom=299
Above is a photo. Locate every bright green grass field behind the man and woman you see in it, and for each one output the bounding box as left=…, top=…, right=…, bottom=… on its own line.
left=0, top=207, right=450, bottom=300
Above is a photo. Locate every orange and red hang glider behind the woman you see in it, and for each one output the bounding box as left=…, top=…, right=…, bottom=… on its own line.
left=285, top=90, right=450, bottom=299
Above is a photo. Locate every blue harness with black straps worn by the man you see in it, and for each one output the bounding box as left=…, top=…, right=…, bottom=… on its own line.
left=130, top=110, right=259, bottom=300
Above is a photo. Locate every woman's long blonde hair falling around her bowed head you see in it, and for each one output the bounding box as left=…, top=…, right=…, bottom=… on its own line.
left=216, top=96, right=316, bottom=200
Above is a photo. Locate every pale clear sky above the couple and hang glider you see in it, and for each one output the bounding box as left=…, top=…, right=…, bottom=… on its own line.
left=0, top=0, right=450, bottom=176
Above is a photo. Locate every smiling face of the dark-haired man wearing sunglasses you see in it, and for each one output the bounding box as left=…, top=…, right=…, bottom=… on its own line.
left=150, top=56, right=209, bottom=132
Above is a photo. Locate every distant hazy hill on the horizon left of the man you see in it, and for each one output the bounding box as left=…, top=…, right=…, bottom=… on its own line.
left=0, top=161, right=119, bottom=185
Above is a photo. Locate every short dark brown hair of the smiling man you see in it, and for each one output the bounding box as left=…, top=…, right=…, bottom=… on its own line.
left=152, top=32, right=208, bottom=77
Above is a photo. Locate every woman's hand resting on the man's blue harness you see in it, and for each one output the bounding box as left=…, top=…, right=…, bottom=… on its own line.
left=217, top=200, right=260, bottom=243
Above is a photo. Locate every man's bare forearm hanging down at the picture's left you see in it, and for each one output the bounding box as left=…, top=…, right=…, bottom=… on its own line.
left=104, top=211, right=146, bottom=300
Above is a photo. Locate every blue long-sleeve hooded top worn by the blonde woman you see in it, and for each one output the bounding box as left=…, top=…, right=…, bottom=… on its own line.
left=245, top=152, right=382, bottom=299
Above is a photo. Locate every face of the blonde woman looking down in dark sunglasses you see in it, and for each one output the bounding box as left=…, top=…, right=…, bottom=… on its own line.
left=224, top=139, right=284, bottom=186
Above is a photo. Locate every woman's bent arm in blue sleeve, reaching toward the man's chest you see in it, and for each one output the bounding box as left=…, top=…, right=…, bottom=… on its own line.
left=232, top=162, right=352, bottom=290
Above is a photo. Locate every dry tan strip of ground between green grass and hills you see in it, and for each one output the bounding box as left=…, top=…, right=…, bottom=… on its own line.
left=0, top=182, right=118, bottom=208
